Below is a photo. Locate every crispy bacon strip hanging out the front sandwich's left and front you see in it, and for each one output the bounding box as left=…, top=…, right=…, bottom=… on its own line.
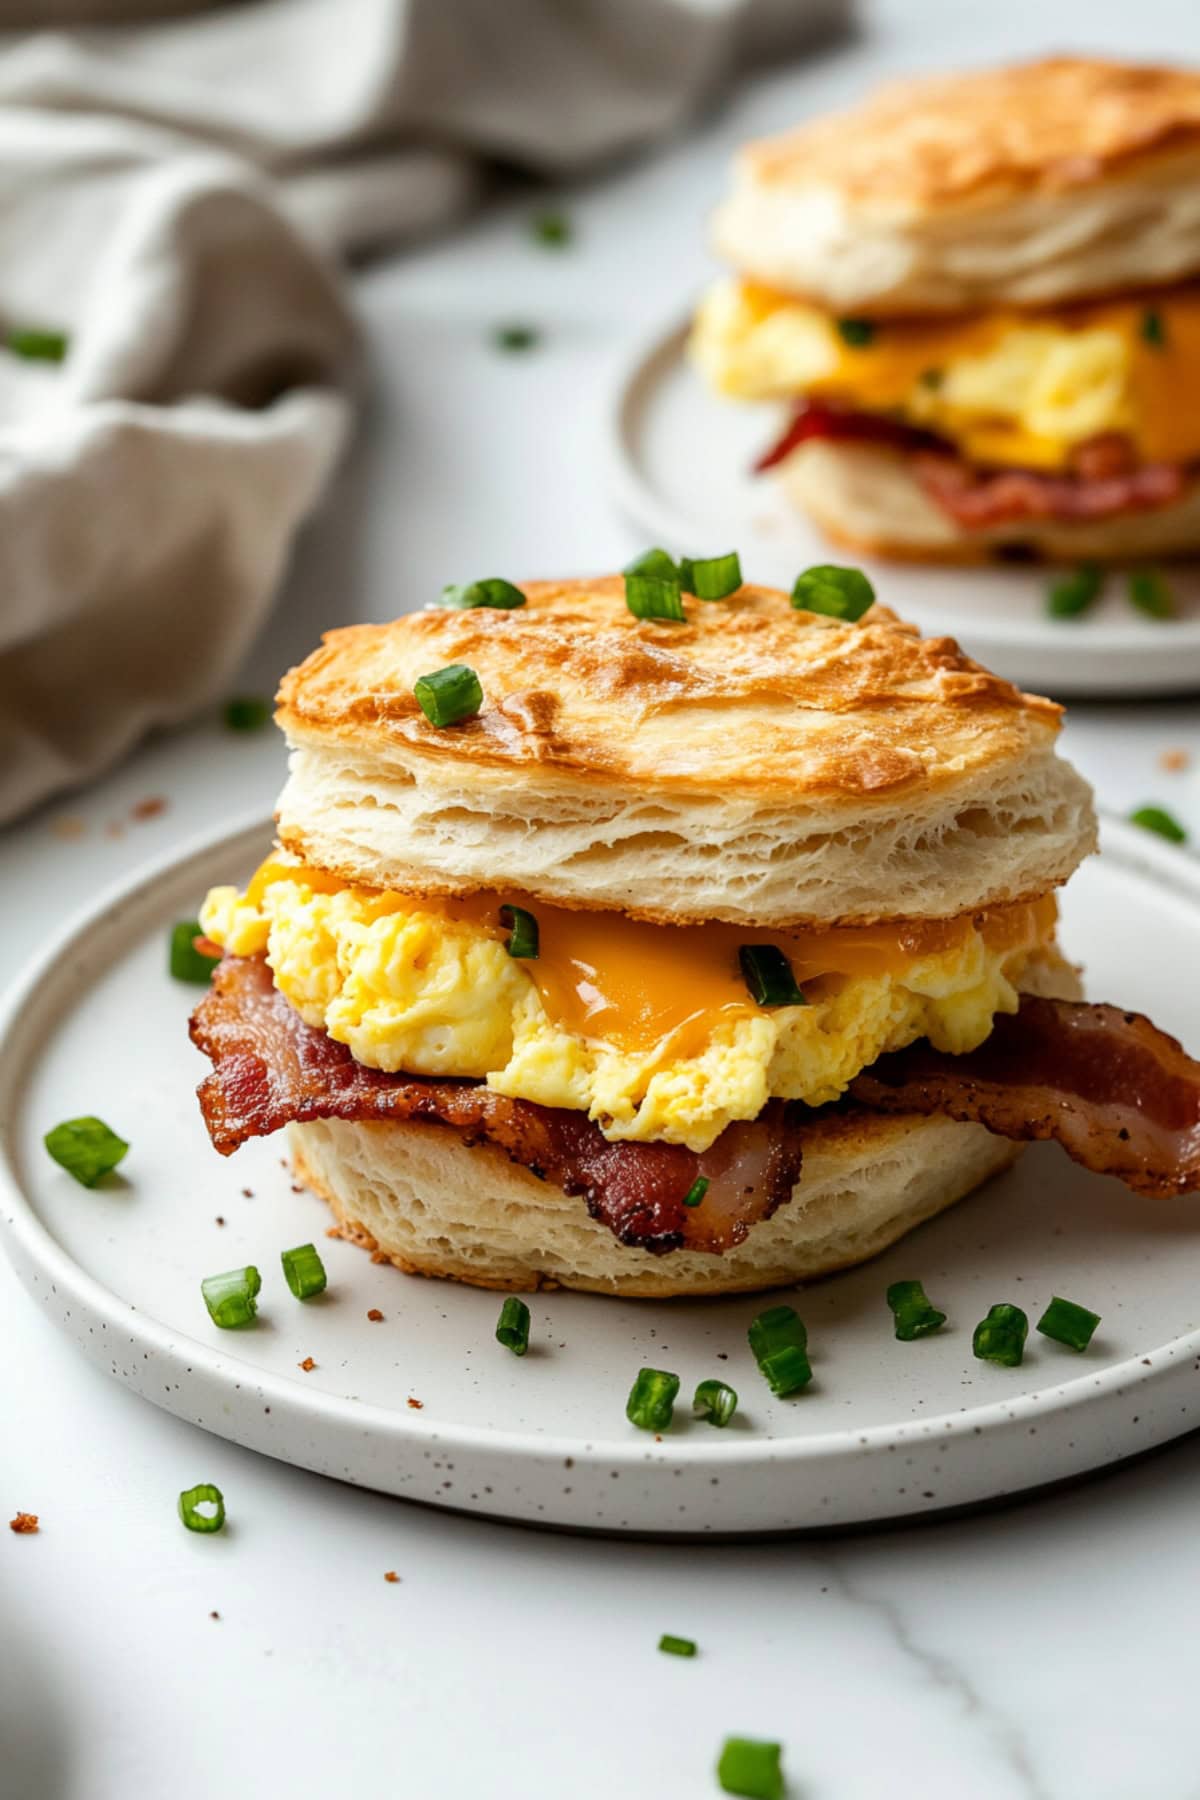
left=191, top=956, right=801, bottom=1255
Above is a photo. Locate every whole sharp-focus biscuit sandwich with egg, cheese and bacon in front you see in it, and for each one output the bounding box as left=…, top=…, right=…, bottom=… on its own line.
left=193, top=565, right=1200, bottom=1296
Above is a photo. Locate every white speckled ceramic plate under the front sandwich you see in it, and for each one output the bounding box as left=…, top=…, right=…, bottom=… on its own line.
left=0, top=823, right=1200, bottom=1532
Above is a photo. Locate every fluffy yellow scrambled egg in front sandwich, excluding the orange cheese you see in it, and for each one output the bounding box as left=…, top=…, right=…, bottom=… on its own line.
left=200, top=871, right=1052, bottom=1150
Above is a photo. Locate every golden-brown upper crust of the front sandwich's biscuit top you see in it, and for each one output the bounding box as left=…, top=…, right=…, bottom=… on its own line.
left=277, top=576, right=1060, bottom=805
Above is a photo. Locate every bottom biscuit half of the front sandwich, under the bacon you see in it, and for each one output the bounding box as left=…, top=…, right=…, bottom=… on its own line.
left=288, top=1112, right=1022, bottom=1300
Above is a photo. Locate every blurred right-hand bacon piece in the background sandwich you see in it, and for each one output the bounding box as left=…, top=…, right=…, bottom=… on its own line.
left=912, top=452, right=1186, bottom=531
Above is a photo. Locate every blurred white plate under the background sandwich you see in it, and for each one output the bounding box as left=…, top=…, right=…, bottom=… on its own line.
left=608, top=324, right=1200, bottom=697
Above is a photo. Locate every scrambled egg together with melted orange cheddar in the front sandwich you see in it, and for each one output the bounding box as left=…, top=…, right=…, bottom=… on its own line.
left=200, top=862, right=1056, bottom=1150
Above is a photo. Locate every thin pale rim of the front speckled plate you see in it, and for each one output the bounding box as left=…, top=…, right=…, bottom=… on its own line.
left=0, top=812, right=1200, bottom=1469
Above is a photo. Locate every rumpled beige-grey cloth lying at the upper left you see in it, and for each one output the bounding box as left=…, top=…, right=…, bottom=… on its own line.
left=0, top=0, right=851, bottom=821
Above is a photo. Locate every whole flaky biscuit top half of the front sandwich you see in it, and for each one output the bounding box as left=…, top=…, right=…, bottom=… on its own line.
left=277, top=576, right=1096, bottom=927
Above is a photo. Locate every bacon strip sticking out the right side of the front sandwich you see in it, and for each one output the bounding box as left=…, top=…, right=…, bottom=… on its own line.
left=851, top=995, right=1200, bottom=1199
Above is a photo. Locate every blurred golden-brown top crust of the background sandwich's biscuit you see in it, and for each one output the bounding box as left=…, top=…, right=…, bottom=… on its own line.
left=743, top=56, right=1200, bottom=212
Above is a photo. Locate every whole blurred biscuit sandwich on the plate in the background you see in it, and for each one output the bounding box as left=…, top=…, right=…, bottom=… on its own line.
left=691, top=58, right=1200, bottom=562
